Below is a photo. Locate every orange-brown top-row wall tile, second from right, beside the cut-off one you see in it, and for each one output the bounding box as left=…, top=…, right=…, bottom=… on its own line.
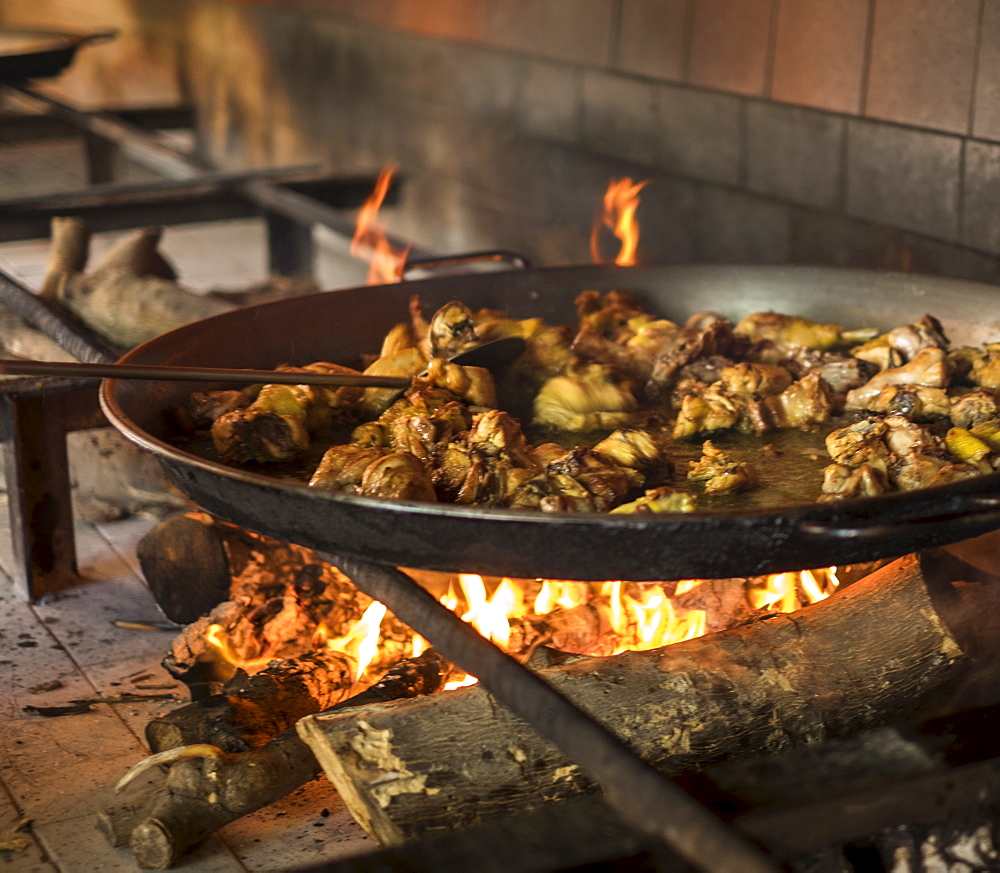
left=865, top=0, right=981, bottom=133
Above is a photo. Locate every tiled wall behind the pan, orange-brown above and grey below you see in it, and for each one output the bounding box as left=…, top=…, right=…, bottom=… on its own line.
left=4, top=0, right=1000, bottom=280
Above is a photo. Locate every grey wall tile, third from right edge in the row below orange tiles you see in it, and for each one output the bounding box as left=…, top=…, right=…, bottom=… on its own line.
left=747, top=101, right=845, bottom=209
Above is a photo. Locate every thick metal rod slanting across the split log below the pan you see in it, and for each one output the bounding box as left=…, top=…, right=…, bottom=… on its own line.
left=328, top=555, right=778, bottom=873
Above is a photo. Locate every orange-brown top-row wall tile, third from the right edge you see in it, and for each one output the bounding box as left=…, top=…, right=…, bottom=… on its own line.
left=771, top=0, right=873, bottom=112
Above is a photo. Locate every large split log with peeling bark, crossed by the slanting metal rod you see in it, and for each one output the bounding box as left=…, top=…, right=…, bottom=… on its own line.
left=298, top=556, right=984, bottom=844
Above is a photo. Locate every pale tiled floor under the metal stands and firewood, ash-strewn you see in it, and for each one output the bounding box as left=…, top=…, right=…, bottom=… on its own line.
left=0, top=121, right=373, bottom=873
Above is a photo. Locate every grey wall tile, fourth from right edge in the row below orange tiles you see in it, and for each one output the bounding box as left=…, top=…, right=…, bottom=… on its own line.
left=653, top=85, right=745, bottom=185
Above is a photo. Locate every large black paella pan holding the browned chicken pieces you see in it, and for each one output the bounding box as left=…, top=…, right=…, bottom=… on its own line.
left=101, top=266, right=1000, bottom=580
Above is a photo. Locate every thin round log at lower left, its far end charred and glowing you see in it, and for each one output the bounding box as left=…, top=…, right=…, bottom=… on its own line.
left=98, top=650, right=450, bottom=869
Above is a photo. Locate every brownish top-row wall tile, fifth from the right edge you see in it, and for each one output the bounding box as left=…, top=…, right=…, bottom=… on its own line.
left=615, top=0, right=691, bottom=82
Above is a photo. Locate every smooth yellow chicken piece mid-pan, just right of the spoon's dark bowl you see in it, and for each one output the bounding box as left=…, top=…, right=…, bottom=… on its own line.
left=533, top=364, right=638, bottom=433
